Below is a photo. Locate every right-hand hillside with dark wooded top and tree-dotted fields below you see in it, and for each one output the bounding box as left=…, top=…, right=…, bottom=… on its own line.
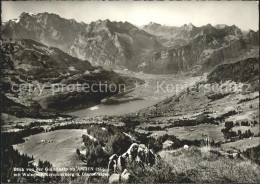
left=125, top=58, right=259, bottom=150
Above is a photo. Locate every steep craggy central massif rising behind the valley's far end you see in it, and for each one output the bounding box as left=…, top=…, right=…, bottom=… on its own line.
left=69, top=20, right=162, bottom=69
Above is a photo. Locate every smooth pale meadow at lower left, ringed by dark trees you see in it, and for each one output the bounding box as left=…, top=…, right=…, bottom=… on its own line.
left=14, top=129, right=86, bottom=167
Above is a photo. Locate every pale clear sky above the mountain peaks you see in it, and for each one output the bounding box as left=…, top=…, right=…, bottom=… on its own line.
left=1, top=1, right=259, bottom=31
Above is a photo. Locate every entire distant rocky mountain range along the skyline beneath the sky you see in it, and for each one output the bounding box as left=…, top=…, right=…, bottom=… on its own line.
left=2, top=13, right=259, bottom=74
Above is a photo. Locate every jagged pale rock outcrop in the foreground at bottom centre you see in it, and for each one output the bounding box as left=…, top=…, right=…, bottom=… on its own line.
left=108, top=143, right=157, bottom=183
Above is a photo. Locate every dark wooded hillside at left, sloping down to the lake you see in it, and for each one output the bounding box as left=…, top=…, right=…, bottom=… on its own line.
left=1, top=39, right=140, bottom=116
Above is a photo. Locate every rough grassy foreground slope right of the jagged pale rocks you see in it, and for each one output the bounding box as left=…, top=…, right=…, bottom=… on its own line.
left=130, top=147, right=260, bottom=183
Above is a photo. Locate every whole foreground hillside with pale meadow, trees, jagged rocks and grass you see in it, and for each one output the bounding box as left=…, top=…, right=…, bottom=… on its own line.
left=3, top=120, right=260, bottom=183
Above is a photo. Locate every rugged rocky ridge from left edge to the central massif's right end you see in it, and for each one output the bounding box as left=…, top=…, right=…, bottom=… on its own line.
left=2, top=13, right=163, bottom=69
